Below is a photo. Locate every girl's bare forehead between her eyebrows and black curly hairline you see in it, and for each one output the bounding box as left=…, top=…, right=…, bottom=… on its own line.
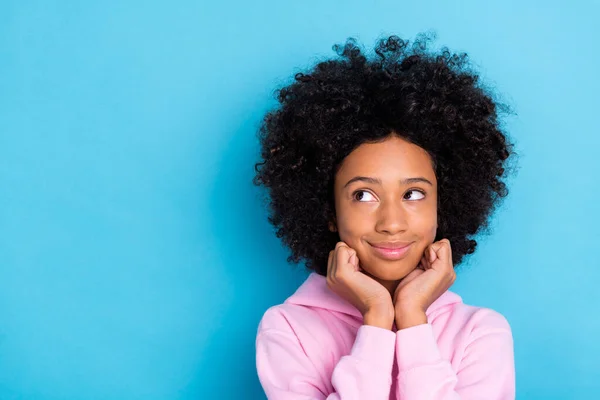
left=338, top=136, right=435, bottom=180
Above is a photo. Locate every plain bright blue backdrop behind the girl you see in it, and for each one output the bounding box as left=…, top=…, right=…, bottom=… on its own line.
left=0, top=0, right=600, bottom=400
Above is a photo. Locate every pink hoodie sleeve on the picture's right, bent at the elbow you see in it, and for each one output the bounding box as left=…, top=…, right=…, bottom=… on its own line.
left=396, top=312, right=515, bottom=400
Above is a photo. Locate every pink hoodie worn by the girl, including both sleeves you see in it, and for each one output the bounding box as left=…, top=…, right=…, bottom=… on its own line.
left=256, top=272, right=515, bottom=400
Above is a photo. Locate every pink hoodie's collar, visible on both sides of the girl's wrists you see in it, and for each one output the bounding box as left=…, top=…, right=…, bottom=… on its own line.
left=285, top=272, right=462, bottom=318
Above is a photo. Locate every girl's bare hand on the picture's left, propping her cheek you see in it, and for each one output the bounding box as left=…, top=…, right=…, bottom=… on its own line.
left=327, top=242, right=394, bottom=329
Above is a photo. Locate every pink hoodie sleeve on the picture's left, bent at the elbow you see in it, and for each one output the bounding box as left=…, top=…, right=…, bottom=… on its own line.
left=256, top=325, right=396, bottom=400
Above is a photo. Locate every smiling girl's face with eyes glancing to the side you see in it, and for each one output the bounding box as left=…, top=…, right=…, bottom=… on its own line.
left=330, top=135, right=437, bottom=281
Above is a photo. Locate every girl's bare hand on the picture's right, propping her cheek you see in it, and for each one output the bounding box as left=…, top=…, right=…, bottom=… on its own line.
left=394, top=239, right=456, bottom=329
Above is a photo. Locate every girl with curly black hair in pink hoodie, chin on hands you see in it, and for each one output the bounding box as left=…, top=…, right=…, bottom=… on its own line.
left=254, top=35, right=515, bottom=400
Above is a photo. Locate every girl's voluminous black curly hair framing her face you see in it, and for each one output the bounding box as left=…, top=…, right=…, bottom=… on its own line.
left=253, top=33, right=515, bottom=276
